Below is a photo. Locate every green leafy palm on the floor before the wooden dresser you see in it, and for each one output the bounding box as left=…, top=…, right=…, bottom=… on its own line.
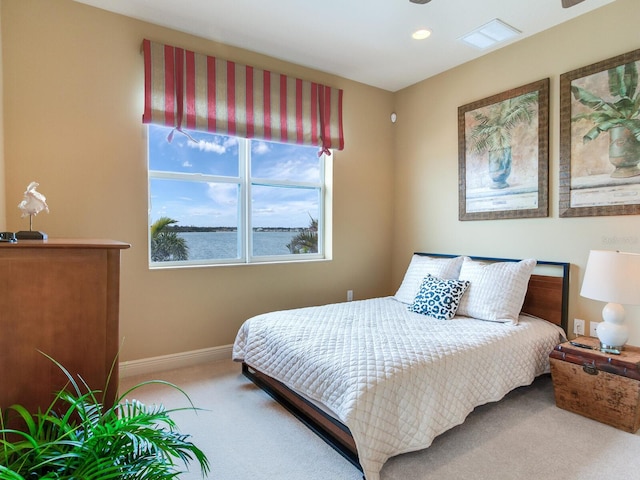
left=0, top=357, right=209, bottom=480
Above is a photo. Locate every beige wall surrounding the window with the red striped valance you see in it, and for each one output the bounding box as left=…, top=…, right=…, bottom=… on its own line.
left=0, top=0, right=393, bottom=360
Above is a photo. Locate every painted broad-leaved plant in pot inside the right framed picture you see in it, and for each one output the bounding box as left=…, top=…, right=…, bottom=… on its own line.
left=571, top=62, right=640, bottom=178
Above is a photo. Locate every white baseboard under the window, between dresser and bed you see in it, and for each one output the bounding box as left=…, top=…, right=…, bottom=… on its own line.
left=120, top=345, right=233, bottom=378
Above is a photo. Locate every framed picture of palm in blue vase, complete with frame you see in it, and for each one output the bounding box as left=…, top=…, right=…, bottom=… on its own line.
left=458, top=78, right=550, bottom=220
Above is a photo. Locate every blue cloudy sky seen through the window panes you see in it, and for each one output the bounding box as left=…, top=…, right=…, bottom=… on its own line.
left=148, top=125, right=321, bottom=227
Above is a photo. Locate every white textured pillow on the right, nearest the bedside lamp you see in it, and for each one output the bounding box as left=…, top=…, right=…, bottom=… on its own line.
left=457, top=257, right=537, bottom=324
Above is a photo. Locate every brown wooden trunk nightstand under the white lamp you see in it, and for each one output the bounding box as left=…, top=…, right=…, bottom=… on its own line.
left=549, top=337, right=640, bottom=433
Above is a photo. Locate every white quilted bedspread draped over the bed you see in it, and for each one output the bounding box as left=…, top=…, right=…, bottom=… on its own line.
left=233, top=297, right=563, bottom=480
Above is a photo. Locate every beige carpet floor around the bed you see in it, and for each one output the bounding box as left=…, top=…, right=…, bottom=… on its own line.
left=121, top=360, right=640, bottom=480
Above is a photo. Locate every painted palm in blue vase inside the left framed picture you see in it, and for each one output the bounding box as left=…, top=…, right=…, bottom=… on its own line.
left=471, top=92, right=538, bottom=189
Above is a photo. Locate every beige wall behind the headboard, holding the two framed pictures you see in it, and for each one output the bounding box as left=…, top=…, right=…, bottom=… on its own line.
left=392, top=0, right=640, bottom=345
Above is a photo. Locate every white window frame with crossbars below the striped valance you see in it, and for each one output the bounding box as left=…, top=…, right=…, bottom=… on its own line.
left=147, top=125, right=333, bottom=270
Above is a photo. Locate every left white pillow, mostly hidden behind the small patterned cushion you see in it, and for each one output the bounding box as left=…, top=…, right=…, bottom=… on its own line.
left=395, top=254, right=464, bottom=304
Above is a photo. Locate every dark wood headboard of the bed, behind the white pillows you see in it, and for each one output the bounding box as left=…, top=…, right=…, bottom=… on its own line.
left=415, top=252, right=571, bottom=333
